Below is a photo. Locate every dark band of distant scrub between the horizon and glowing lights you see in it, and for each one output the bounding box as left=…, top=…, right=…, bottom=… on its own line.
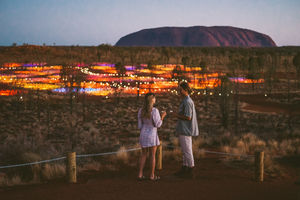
left=0, top=44, right=300, bottom=70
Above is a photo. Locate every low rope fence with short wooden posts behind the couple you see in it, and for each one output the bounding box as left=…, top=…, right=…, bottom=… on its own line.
left=0, top=142, right=264, bottom=183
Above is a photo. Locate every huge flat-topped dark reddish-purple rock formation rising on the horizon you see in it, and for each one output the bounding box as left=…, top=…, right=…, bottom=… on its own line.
left=116, top=26, right=276, bottom=47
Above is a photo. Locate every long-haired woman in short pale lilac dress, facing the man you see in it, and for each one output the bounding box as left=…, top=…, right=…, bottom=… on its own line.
left=138, top=93, right=166, bottom=181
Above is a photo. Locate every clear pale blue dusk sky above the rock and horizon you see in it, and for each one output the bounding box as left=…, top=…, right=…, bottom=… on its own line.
left=0, top=0, right=300, bottom=46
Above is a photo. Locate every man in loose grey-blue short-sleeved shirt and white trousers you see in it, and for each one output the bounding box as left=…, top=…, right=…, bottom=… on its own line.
left=174, top=82, right=199, bottom=177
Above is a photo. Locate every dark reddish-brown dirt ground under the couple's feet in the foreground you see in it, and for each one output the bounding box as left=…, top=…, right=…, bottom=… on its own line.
left=0, top=157, right=300, bottom=200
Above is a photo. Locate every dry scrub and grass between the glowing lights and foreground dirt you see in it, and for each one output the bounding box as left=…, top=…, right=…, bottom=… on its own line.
left=1, top=90, right=300, bottom=185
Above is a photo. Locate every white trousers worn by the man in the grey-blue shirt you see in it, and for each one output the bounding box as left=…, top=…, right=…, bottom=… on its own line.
left=179, top=135, right=195, bottom=167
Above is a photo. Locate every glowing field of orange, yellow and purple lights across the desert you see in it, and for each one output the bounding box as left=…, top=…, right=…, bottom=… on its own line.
left=0, top=63, right=263, bottom=97
